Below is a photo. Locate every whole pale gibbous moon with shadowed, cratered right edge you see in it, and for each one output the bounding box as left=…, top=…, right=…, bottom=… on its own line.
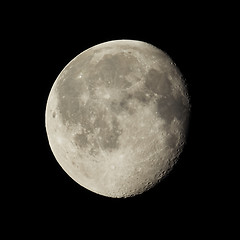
left=45, top=40, right=190, bottom=198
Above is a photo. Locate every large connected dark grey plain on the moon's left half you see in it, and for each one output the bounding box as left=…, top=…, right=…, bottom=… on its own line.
left=57, top=54, right=137, bottom=155
